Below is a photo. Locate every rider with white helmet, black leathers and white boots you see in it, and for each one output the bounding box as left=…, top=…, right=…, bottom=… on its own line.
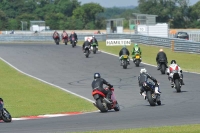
left=138, top=68, right=161, bottom=100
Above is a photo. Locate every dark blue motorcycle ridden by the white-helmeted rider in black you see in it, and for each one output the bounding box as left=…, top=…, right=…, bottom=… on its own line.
left=143, top=82, right=161, bottom=106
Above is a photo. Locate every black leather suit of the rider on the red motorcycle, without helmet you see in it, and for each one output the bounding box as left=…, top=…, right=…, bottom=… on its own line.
left=92, top=78, right=113, bottom=98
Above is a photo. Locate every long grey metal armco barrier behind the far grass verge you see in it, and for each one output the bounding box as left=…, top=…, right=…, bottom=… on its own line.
left=0, top=34, right=200, bottom=53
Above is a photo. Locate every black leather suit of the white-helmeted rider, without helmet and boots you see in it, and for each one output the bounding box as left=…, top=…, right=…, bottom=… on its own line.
left=138, top=73, right=157, bottom=93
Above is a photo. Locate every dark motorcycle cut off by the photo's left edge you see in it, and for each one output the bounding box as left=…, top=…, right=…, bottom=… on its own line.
left=0, top=101, right=12, bottom=123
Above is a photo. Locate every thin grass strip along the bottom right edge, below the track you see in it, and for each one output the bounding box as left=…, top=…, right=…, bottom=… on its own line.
left=72, top=124, right=200, bottom=133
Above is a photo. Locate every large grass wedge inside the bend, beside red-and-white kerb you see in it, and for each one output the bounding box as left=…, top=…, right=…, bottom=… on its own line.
left=0, top=60, right=97, bottom=117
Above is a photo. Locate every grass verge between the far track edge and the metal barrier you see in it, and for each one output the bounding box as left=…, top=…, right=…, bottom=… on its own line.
left=81, top=42, right=200, bottom=73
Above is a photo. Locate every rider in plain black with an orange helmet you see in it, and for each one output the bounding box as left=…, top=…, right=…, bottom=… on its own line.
left=156, top=49, right=168, bottom=70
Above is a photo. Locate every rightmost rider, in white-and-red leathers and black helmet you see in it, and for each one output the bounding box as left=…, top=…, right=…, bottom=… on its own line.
left=167, top=60, right=185, bottom=88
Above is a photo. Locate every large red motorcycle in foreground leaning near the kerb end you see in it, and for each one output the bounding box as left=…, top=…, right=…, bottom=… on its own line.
left=92, top=88, right=120, bottom=112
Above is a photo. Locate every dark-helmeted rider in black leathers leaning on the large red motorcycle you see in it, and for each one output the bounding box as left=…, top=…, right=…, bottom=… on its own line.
left=92, top=73, right=113, bottom=101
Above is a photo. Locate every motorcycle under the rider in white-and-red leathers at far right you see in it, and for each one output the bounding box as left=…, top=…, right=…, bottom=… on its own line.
left=173, top=71, right=182, bottom=92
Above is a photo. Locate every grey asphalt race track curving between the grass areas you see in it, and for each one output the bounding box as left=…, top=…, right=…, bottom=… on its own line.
left=0, top=43, right=200, bottom=133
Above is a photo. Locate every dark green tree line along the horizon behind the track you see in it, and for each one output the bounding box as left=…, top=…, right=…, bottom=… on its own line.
left=0, top=0, right=200, bottom=30
